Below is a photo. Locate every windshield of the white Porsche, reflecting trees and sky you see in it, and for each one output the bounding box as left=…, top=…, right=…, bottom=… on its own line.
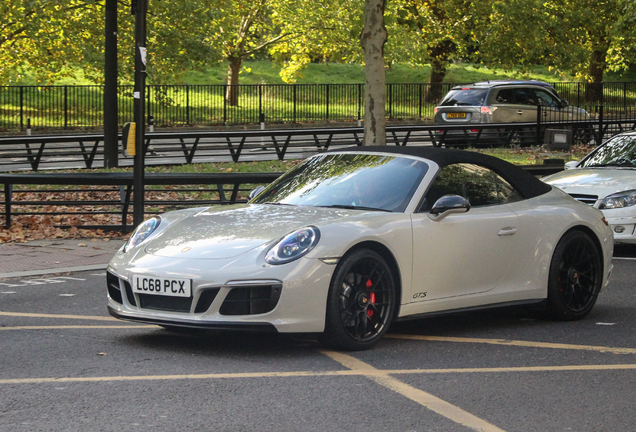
left=252, top=153, right=428, bottom=212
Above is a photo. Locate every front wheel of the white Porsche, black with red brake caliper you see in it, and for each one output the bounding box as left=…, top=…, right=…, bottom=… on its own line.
left=322, top=249, right=396, bottom=351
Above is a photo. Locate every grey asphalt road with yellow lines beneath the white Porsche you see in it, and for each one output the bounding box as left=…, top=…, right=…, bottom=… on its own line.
left=0, top=249, right=636, bottom=432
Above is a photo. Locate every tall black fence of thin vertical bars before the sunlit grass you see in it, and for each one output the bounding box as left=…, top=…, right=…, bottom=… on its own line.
left=0, top=82, right=636, bottom=132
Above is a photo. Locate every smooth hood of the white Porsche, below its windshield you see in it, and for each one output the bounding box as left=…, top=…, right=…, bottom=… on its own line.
left=145, top=204, right=361, bottom=259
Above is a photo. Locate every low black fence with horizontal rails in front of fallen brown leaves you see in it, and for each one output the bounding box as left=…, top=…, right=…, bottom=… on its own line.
left=0, top=165, right=563, bottom=232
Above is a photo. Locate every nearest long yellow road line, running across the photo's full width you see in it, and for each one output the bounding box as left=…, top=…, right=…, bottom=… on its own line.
left=0, top=364, right=636, bottom=384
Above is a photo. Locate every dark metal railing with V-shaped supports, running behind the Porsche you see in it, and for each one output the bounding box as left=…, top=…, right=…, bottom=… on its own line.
left=0, top=116, right=636, bottom=172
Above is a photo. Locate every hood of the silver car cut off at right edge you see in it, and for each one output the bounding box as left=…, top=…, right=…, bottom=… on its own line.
left=543, top=168, right=636, bottom=199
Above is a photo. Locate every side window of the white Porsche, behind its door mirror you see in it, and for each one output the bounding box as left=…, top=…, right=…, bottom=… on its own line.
left=422, top=164, right=523, bottom=211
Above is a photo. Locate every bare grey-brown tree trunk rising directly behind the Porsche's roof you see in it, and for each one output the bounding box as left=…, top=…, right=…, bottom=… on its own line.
left=360, top=0, right=387, bottom=146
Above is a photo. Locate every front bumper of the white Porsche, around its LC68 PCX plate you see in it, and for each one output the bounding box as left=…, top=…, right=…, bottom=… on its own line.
left=107, top=252, right=335, bottom=333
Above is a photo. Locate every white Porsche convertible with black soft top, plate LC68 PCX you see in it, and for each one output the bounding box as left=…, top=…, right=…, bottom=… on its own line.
left=107, top=147, right=613, bottom=350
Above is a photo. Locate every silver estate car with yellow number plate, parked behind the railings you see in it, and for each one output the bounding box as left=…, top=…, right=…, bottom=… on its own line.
left=435, top=81, right=590, bottom=146
